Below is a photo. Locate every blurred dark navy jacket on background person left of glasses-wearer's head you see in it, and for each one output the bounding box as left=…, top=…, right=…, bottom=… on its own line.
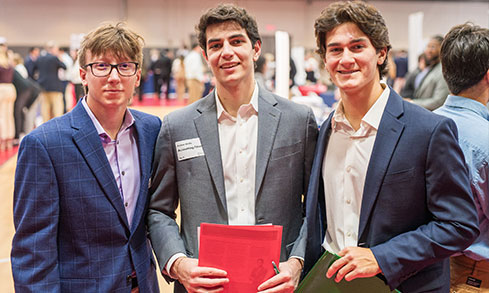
left=34, top=53, right=66, bottom=92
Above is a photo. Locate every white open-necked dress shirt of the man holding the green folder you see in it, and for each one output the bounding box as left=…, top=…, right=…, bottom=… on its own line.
left=322, top=84, right=390, bottom=253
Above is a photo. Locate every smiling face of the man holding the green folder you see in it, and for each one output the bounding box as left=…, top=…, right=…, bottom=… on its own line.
left=324, top=22, right=387, bottom=93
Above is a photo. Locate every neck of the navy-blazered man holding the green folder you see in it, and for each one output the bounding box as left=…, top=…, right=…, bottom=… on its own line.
left=340, top=80, right=384, bottom=130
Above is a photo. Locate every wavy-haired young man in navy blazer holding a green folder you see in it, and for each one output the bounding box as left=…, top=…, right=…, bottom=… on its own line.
left=305, top=1, right=479, bottom=293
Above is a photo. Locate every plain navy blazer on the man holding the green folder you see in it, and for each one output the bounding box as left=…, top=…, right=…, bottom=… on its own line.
left=305, top=89, right=479, bottom=293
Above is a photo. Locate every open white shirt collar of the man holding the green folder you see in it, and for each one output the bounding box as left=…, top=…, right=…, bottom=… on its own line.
left=331, top=83, right=390, bottom=130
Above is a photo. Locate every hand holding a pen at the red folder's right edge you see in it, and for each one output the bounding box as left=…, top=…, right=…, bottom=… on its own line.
left=258, top=258, right=302, bottom=293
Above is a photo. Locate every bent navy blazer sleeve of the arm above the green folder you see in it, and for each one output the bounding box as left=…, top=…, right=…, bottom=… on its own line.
left=371, top=119, right=479, bottom=288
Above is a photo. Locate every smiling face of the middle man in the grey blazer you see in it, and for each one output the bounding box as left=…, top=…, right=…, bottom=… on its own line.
left=205, top=21, right=261, bottom=87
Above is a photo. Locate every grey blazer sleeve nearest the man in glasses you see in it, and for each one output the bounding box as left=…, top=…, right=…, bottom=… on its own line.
left=148, top=115, right=186, bottom=278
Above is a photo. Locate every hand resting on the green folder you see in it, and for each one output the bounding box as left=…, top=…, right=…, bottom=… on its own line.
left=326, top=247, right=382, bottom=282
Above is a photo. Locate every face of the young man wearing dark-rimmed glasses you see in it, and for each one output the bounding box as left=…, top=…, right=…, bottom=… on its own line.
left=80, top=51, right=141, bottom=113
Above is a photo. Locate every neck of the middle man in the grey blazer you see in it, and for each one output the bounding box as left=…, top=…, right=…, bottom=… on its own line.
left=216, top=80, right=255, bottom=117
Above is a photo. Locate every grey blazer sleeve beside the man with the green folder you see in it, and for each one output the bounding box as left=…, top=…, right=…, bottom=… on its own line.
left=290, top=108, right=318, bottom=259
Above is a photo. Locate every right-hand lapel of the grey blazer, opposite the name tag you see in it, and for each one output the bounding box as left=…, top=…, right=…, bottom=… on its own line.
left=255, top=87, right=281, bottom=197
